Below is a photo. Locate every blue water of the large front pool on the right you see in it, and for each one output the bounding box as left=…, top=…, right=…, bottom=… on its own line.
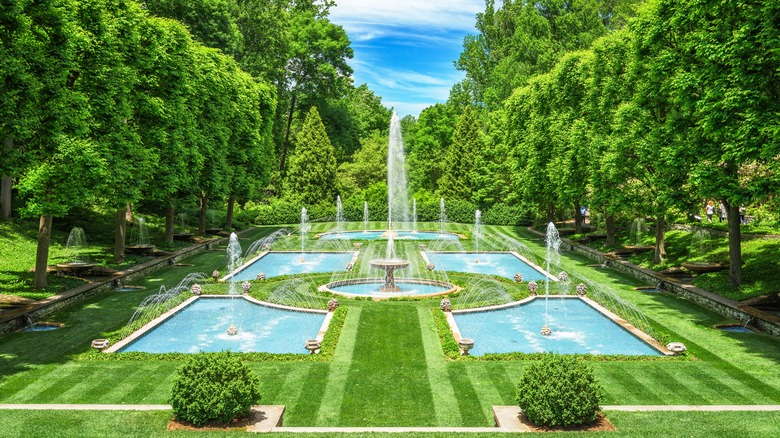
left=453, top=298, right=661, bottom=356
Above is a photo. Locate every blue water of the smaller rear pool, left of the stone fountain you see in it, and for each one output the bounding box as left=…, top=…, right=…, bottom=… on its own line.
left=227, top=252, right=353, bottom=281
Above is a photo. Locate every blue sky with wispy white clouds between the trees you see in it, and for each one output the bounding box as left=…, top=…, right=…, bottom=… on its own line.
left=330, top=0, right=485, bottom=117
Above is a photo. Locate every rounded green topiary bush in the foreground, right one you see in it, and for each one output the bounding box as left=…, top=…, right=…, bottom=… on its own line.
left=517, top=354, right=603, bottom=427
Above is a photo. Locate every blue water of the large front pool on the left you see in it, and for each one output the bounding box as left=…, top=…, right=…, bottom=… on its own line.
left=120, top=297, right=325, bottom=353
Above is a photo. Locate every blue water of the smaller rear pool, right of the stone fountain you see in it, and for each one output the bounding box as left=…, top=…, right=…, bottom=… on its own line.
left=425, top=252, right=546, bottom=281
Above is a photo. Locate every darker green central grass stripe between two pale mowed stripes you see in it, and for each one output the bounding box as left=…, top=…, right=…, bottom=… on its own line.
left=340, top=302, right=436, bottom=426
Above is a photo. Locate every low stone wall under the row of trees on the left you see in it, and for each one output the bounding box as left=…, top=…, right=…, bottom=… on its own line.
left=0, top=238, right=226, bottom=333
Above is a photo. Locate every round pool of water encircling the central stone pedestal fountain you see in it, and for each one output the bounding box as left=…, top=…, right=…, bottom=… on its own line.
left=319, top=278, right=459, bottom=299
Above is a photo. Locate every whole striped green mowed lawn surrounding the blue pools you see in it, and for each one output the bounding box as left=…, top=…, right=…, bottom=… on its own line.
left=0, top=224, right=780, bottom=436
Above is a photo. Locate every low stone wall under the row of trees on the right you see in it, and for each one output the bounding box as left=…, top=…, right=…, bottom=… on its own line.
left=528, top=228, right=780, bottom=336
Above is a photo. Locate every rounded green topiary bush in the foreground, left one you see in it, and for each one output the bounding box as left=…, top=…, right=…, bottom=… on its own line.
left=169, top=352, right=260, bottom=426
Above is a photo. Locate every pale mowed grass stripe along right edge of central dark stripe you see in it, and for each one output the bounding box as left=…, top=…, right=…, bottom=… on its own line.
left=417, top=306, right=463, bottom=425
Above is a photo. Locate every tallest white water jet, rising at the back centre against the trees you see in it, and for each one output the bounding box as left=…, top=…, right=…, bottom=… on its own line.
left=387, top=112, right=409, bottom=230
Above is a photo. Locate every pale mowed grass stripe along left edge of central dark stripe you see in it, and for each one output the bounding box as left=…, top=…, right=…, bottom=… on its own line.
left=316, top=307, right=362, bottom=426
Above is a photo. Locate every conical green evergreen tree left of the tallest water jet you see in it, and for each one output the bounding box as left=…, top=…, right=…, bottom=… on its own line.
left=286, top=107, right=336, bottom=205
